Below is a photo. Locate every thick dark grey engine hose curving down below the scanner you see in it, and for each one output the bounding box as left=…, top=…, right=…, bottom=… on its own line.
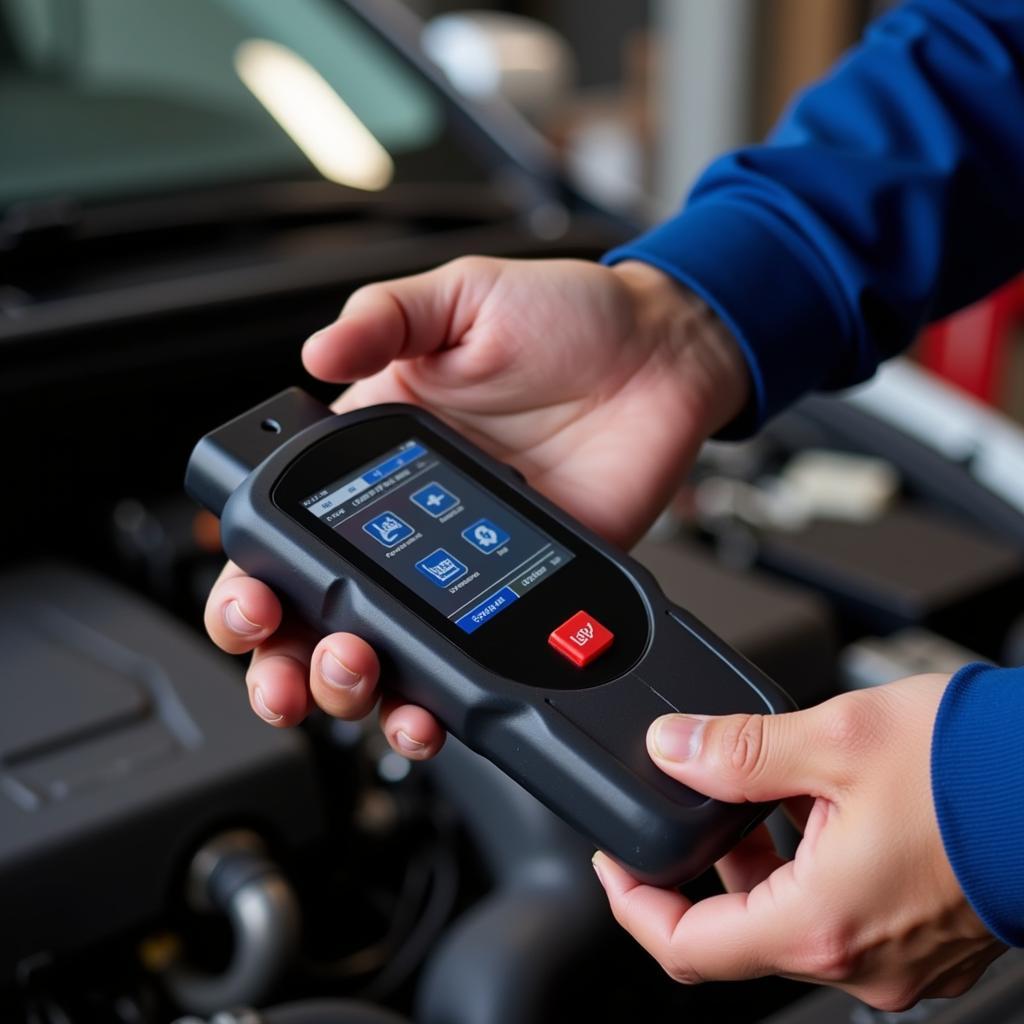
left=415, top=736, right=611, bottom=1024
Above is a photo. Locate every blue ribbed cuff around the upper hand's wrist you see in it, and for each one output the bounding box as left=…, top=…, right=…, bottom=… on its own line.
left=602, top=200, right=848, bottom=438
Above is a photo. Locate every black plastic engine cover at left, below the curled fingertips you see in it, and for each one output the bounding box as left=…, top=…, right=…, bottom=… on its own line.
left=0, top=564, right=323, bottom=983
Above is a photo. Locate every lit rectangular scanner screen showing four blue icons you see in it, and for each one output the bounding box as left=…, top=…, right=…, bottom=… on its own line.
left=302, top=438, right=572, bottom=633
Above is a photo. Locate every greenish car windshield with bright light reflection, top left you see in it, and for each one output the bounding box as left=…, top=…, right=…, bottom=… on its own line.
left=0, top=0, right=486, bottom=206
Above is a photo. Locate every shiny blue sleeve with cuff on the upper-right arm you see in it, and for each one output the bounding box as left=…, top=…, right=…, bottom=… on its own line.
left=605, top=0, right=1024, bottom=436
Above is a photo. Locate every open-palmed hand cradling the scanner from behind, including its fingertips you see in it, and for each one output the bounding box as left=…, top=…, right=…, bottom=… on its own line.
left=206, top=257, right=750, bottom=758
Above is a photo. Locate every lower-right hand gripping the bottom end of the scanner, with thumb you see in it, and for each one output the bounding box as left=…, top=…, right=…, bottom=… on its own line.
left=594, top=676, right=1006, bottom=1011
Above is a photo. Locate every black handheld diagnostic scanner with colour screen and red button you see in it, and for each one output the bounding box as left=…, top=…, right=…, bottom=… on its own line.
left=185, top=388, right=792, bottom=885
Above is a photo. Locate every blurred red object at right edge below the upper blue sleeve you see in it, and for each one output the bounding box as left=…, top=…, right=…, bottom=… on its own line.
left=919, top=278, right=1024, bottom=406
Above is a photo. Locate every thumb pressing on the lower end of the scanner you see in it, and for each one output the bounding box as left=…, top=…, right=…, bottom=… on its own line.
left=647, top=701, right=848, bottom=804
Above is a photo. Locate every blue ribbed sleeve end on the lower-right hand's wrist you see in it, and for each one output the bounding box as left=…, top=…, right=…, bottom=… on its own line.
left=932, top=665, right=1024, bottom=946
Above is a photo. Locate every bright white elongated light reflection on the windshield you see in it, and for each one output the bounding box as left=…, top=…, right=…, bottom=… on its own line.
left=234, top=39, right=394, bottom=191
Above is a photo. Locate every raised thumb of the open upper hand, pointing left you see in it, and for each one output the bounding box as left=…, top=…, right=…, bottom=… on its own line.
left=302, top=257, right=497, bottom=384
